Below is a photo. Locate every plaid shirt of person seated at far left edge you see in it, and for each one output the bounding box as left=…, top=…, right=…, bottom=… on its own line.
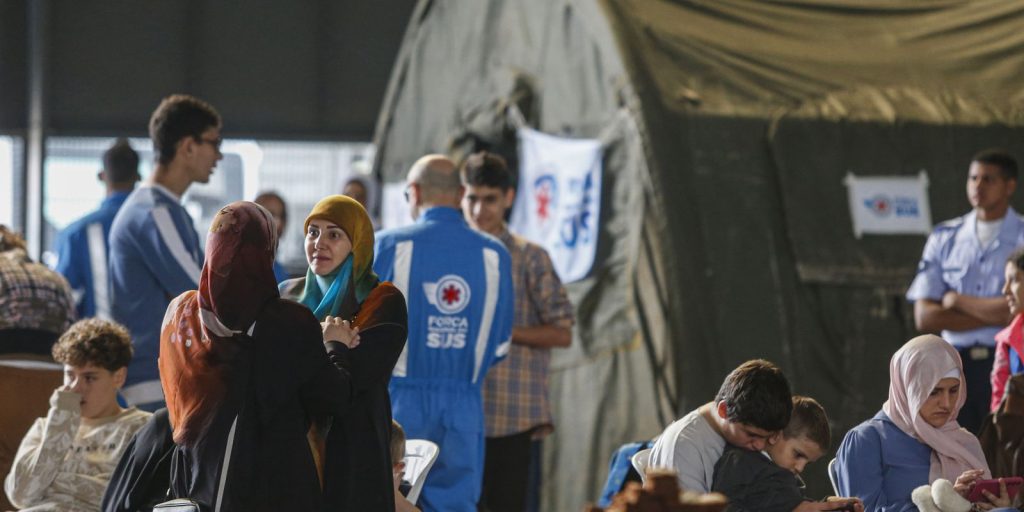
left=0, top=249, right=75, bottom=334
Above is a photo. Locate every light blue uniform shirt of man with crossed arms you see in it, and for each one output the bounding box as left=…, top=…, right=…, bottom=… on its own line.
left=906, top=208, right=1024, bottom=348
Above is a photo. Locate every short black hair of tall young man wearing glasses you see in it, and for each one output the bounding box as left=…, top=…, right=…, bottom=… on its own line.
left=150, top=94, right=220, bottom=165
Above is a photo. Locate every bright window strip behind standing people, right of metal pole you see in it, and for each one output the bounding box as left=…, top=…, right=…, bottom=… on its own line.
left=40, top=137, right=376, bottom=274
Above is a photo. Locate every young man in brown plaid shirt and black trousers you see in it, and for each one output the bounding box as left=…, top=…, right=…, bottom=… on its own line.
left=461, top=152, right=573, bottom=512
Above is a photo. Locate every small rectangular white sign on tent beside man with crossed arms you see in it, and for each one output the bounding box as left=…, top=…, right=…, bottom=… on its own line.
left=843, top=170, right=932, bottom=239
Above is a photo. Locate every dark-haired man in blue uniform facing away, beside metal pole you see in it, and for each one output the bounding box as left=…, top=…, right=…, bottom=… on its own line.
left=53, top=138, right=139, bottom=318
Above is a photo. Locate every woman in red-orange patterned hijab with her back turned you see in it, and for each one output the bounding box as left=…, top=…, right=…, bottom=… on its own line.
left=159, top=202, right=352, bottom=510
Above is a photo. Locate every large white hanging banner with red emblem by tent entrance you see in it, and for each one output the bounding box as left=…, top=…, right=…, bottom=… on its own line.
left=510, top=128, right=601, bottom=283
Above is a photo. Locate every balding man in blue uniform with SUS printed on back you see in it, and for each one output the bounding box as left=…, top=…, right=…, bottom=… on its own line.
left=374, top=155, right=514, bottom=512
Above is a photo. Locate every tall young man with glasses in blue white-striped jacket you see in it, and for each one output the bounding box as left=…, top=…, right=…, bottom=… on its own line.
left=110, top=94, right=222, bottom=411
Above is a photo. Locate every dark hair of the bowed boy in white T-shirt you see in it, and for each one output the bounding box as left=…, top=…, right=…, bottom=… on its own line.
left=715, top=359, right=793, bottom=432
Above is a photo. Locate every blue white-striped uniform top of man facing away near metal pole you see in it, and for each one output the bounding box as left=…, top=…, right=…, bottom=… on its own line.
left=53, top=191, right=129, bottom=318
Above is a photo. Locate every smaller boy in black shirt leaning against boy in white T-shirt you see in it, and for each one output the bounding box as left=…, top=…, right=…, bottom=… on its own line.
left=712, top=396, right=863, bottom=512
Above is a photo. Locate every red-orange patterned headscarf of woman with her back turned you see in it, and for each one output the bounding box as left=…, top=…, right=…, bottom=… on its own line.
left=160, top=201, right=279, bottom=445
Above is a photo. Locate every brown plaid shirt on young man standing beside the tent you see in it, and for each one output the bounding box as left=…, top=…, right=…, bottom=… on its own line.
left=483, top=228, right=573, bottom=437
